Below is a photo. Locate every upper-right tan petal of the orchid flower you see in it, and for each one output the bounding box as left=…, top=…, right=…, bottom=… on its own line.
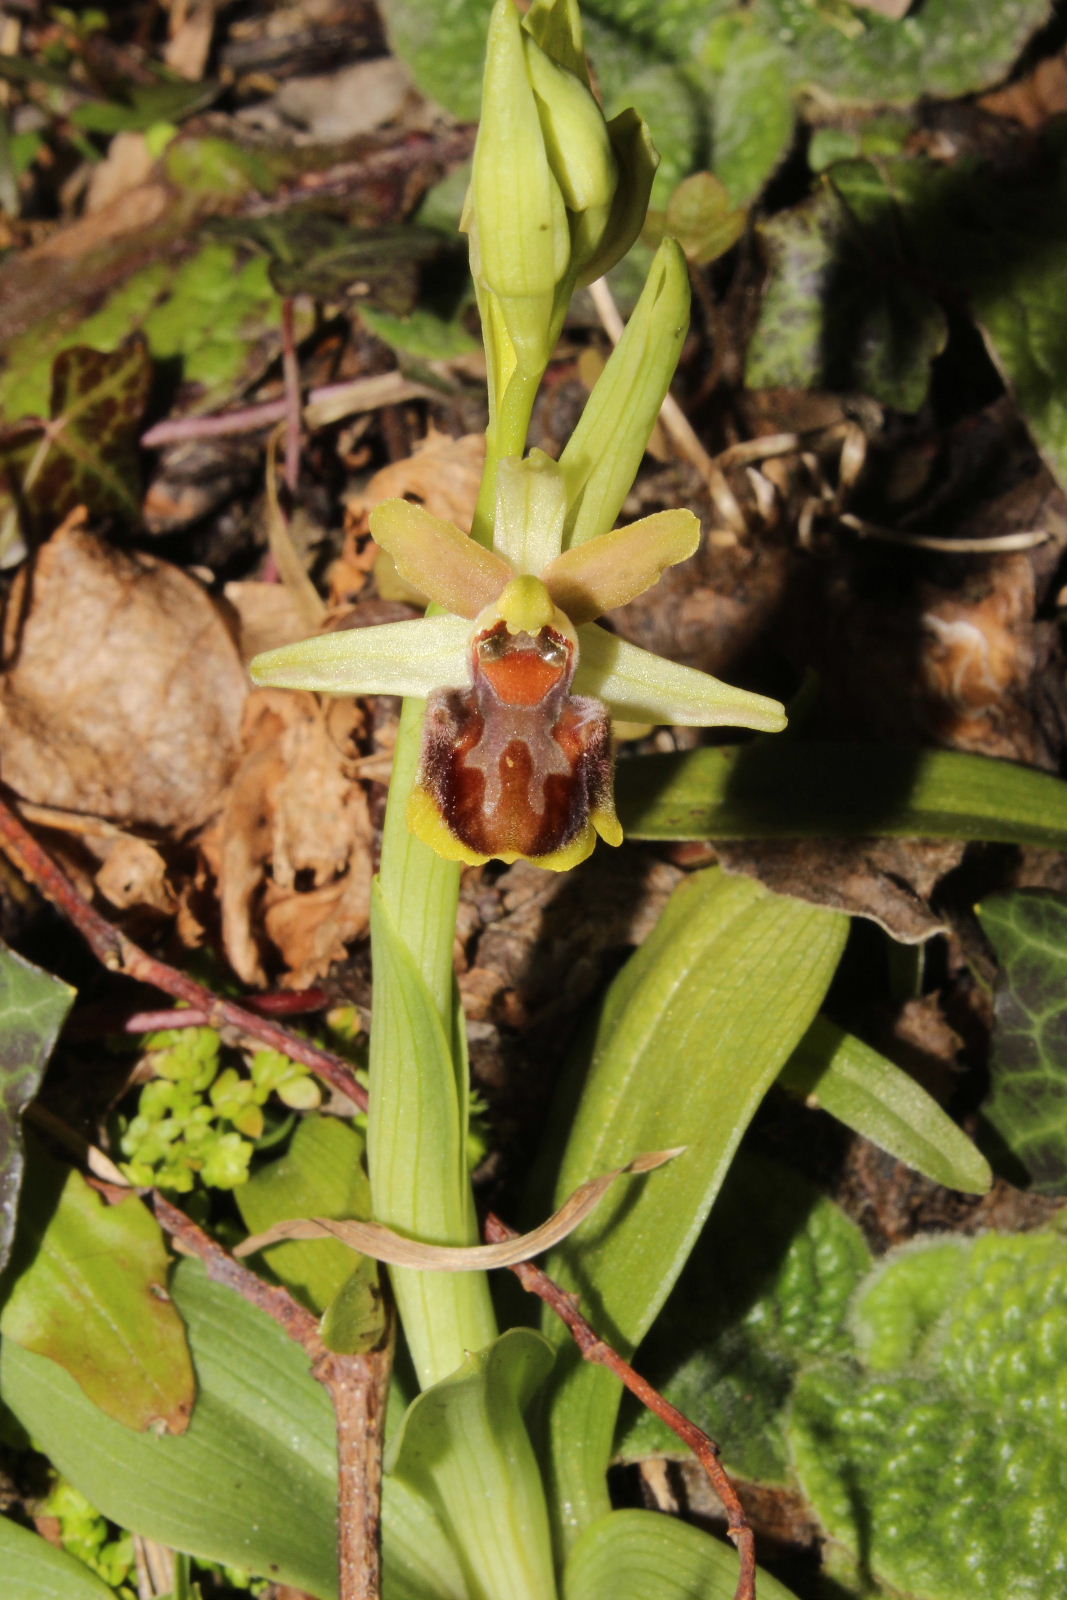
left=544, top=510, right=701, bottom=624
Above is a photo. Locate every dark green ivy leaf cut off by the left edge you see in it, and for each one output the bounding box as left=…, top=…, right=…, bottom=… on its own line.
left=0, top=944, right=74, bottom=1272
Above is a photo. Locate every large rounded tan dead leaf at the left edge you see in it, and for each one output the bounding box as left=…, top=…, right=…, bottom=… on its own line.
left=0, top=515, right=248, bottom=834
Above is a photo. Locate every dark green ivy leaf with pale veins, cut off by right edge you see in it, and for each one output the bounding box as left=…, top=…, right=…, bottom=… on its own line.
left=977, top=890, right=1067, bottom=1195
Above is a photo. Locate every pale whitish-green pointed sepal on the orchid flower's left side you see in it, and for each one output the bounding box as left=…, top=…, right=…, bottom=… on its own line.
left=248, top=616, right=470, bottom=698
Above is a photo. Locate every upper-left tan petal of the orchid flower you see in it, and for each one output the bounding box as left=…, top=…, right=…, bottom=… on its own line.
left=371, top=499, right=512, bottom=618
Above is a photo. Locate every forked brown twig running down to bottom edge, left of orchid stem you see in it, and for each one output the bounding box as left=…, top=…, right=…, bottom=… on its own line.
left=150, top=1189, right=392, bottom=1600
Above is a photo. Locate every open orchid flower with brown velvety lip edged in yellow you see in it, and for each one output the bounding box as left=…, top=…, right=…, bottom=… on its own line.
left=251, top=451, right=785, bottom=872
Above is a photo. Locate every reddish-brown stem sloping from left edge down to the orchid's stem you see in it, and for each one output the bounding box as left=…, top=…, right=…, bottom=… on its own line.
left=0, top=798, right=366, bottom=1110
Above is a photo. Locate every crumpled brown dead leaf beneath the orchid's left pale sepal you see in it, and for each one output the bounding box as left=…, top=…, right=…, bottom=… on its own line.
left=203, top=690, right=373, bottom=989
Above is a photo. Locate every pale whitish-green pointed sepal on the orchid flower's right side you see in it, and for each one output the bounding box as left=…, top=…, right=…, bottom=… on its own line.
left=574, top=622, right=785, bottom=733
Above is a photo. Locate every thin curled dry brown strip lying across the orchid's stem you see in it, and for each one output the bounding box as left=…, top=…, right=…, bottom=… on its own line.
left=234, top=1146, right=683, bottom=1272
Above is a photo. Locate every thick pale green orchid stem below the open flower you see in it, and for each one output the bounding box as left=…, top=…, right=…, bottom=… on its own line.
left=366, top=699, right=496, bottom=1387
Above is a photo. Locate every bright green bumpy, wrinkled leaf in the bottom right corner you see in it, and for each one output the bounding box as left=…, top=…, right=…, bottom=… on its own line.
left=789, top=1234, right=1067, bottom=1600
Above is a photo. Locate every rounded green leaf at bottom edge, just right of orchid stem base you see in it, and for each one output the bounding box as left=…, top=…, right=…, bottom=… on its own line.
left=563, top=1510, right=792, bottom=1600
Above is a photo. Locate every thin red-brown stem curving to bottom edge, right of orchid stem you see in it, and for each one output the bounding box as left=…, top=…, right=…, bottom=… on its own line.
left=485, top=1211, right=755, bottom=1600
